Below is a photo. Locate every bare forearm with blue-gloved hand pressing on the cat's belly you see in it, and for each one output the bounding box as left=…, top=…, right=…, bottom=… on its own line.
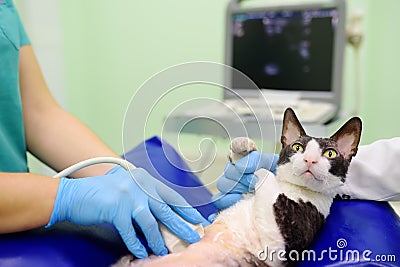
left=0, top=167, right=208, bottom=258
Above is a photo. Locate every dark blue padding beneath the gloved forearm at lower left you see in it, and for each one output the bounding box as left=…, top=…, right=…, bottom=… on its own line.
left=0, top=223, right=128, bottom=267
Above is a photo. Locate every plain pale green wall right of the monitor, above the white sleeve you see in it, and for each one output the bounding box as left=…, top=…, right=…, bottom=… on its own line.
left=361, top=0, right=400, bottom=144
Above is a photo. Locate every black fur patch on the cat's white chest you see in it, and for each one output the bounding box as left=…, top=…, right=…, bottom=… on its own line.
left=273, top=194, right=325, bottom=262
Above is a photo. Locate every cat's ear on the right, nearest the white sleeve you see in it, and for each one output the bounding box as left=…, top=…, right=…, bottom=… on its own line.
left=331, top=117, right=362, bottom=160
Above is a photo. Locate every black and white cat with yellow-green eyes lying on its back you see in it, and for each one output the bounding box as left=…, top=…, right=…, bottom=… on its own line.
left=115, top=108, right=362, bottom=266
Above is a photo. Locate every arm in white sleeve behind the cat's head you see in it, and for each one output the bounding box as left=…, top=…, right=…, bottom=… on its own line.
left=341, top=137, right=400, bottom=201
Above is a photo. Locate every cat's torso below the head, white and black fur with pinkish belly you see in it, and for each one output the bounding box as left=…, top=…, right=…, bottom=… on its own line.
left=114, top=173, right=324, bottom=267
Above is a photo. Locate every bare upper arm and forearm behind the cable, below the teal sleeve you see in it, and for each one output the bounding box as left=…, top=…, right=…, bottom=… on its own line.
left=19, top=45, right=118, bottom=177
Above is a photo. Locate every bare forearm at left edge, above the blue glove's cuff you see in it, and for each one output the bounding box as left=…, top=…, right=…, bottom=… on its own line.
left=0, top=173, right=59, bottom=233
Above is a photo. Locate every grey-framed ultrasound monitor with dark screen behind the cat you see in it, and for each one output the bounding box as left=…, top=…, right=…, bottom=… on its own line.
left=226, top=0, right=346, bottom=105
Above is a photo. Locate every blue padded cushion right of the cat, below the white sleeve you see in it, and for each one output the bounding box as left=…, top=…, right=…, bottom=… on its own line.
left=299, top=200, right=400, bottom=267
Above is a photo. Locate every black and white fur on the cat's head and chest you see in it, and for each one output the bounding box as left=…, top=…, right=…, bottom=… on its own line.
left=216, top=109, right=361, bottom=266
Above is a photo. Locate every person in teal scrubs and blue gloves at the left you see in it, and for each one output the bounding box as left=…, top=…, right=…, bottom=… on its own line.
left=0, top=0, right=206, bottom=258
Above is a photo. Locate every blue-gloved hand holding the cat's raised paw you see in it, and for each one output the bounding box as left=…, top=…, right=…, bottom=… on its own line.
left=210, top=151, right=279, bottom=213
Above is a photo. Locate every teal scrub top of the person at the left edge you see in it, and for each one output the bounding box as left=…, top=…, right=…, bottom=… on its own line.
left=0, top=0, right=29, bottom=172
